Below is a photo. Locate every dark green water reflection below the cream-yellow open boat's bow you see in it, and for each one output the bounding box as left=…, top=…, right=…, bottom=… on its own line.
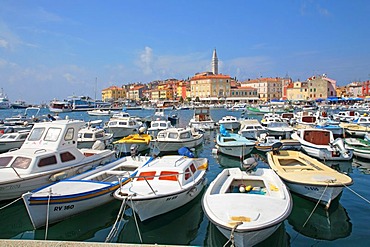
left=288, top=194, right=352, bottom=240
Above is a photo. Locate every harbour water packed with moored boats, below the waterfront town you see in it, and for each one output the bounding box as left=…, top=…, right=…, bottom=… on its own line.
left=0, top=106, right=370, bottom=246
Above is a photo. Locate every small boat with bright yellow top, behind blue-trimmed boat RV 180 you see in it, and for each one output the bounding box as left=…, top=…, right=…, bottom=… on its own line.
left=113, top=134, right=152, bottom=156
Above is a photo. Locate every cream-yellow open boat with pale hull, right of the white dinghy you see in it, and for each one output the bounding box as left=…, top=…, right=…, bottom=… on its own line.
left=267, top=149, right=353, bottom=208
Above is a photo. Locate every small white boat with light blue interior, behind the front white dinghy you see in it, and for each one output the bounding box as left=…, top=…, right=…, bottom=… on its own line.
left=216, top=125, right=255, bottom=158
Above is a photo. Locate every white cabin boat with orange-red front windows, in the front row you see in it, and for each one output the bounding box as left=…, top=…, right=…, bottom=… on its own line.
left=114, top=155, right=208, bottom=221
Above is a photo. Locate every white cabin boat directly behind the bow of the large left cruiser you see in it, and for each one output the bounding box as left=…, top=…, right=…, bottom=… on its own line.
left=77, top=120, right=113, bottom=148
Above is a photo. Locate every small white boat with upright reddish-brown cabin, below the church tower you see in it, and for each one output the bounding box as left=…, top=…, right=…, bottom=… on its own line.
left=189, top=107, right=216, bottom=130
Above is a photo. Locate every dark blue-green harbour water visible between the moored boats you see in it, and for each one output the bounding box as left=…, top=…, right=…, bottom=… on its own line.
left=0, top=109, right=370, bottom=246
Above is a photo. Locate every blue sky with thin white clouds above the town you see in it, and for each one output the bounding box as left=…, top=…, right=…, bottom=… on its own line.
left=0, top=0, right=370, bottom=104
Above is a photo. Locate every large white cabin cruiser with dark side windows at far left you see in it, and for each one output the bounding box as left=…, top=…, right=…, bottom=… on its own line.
left=0, top=120, right=115, bottom=200
